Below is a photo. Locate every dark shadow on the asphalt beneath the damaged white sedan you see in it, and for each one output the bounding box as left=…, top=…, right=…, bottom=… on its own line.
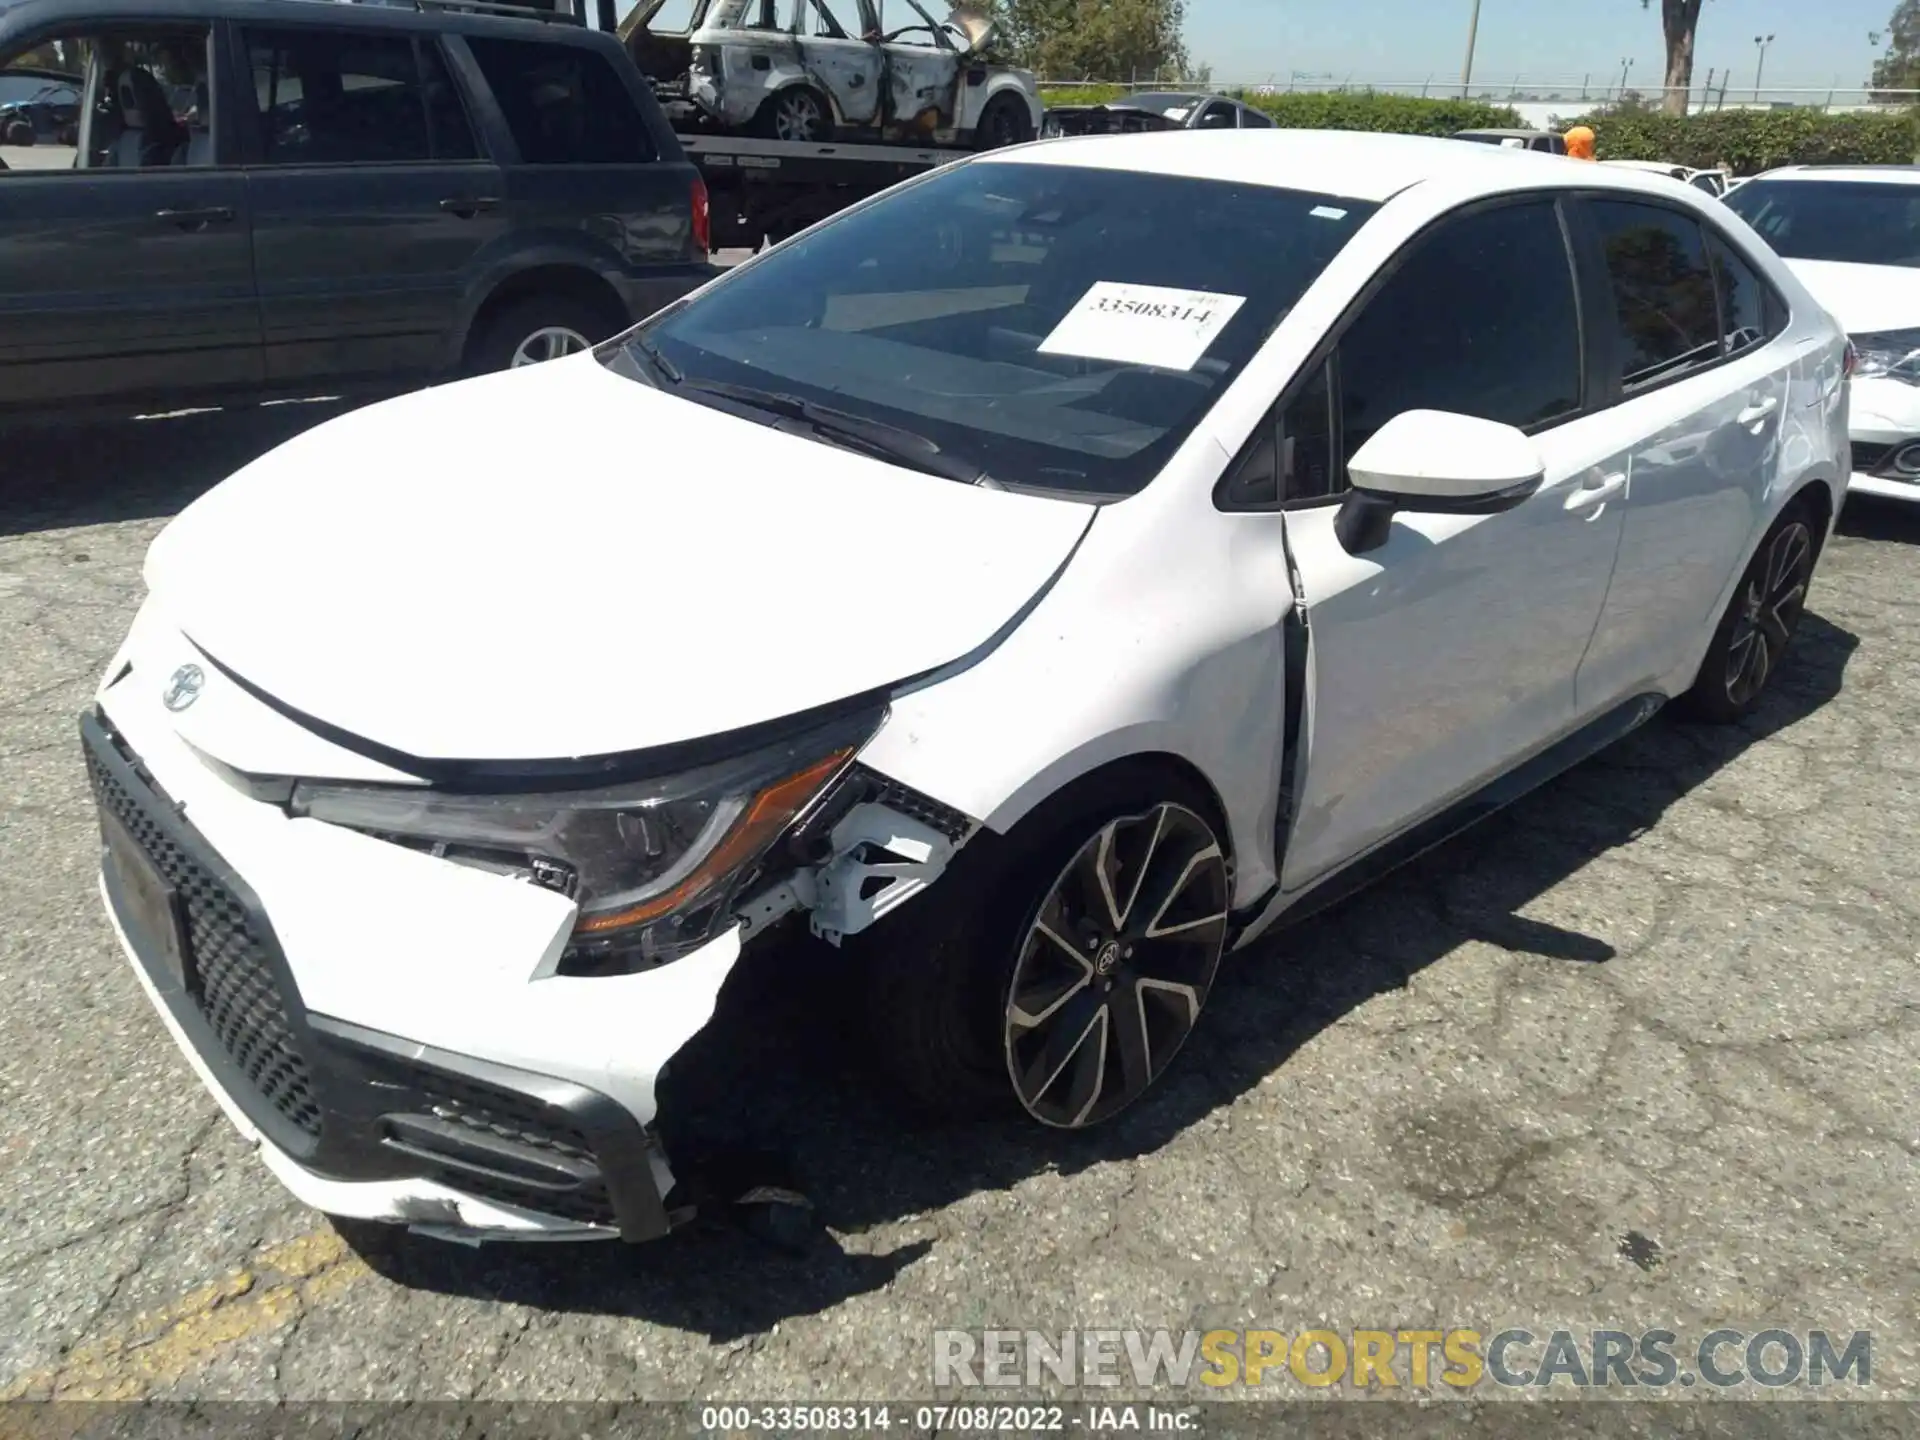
left=345, top=610, right=1859, bottom=1342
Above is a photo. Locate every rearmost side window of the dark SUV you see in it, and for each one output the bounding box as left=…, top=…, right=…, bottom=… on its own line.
left=467, top=35, right=653, bottom=165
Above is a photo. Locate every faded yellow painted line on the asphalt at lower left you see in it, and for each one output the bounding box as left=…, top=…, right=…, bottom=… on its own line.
left=0, top=1229, right=371, bottom=1402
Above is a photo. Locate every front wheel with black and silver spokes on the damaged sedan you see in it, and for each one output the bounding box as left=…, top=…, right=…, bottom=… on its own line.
left=864, top=776, right=1229, bottom=1129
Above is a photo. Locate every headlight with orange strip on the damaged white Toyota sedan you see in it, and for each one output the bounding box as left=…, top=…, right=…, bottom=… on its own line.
left=288, top=710, right=881, bottom=972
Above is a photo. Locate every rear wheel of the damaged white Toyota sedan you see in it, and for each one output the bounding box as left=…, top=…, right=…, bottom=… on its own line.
left=1682, top=505, right=1820, bottom=724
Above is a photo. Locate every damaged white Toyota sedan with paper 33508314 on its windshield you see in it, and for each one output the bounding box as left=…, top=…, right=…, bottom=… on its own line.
left=83, top=131, right=1847, bottom=1240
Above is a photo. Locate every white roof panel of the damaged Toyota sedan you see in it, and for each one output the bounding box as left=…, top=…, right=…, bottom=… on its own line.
left=973, top=129, right=1697, bottom=204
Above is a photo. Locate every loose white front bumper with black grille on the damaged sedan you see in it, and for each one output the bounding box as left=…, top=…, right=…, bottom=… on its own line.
left=81, top=689, right=739, bottom=1240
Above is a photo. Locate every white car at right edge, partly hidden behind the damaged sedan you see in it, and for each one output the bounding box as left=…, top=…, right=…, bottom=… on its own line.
left=1726, top=165, right=1920, bottom=501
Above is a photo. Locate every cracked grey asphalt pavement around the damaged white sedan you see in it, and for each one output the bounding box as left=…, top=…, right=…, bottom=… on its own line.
left=0, top=405, right=1920, bottom=1400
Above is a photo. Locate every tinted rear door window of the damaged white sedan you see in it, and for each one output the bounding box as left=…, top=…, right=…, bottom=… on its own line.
left=1592, top=200, right=1720, bottom=390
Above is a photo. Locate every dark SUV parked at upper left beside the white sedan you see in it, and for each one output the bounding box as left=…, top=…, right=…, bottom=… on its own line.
left=0, top=0, right=712, bottom=420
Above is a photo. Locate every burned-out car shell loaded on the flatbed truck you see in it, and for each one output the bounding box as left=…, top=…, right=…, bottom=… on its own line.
left=620, top=0, right=1043, bottom=150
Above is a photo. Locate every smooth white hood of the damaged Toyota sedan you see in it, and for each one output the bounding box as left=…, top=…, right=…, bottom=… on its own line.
left=146, top=355, right=1094, bottom=760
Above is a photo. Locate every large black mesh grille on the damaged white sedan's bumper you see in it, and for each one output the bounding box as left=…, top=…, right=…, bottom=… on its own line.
left=86, top=737, right=321, bottom=1139
